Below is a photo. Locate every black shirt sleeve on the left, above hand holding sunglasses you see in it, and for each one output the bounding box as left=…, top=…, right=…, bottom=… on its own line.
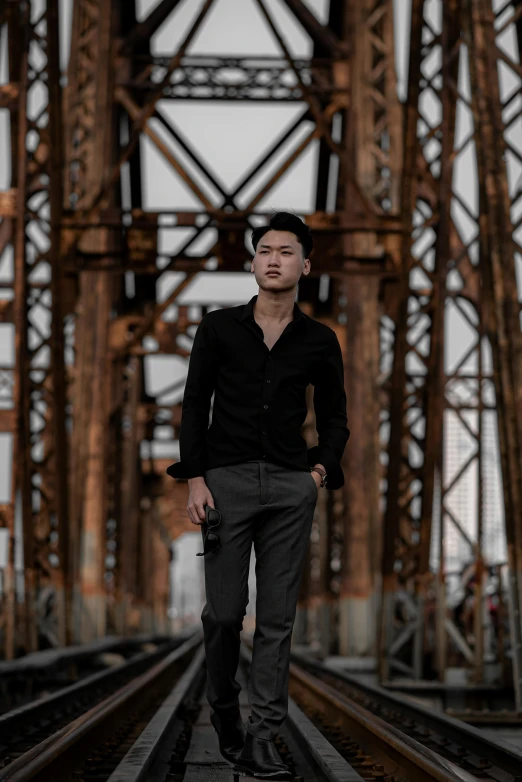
left=167, top=313, right=219, bottom=479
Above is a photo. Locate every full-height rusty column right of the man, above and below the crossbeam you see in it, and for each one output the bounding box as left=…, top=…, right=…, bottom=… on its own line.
left=338, top=0, right=402, bottom=654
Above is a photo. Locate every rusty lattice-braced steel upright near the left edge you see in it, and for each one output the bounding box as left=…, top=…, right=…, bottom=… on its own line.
left=4, top=0, right=69, bottom=654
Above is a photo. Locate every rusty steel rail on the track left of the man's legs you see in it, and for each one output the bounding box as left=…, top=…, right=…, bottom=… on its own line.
left=0, top=631, right=202, bottom=782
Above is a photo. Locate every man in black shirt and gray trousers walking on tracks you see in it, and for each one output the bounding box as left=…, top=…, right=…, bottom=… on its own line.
left=167, top=212, right=350, bottom=779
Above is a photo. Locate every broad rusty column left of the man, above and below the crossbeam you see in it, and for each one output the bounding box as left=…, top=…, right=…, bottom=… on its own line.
left=67, top=0, right=118, bottom=641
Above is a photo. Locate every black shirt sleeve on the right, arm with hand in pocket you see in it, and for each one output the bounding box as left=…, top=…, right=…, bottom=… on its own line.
left=307, top=332, right=350, bottom=489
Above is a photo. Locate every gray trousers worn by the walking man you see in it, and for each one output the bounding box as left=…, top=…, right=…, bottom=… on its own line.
left=201, top=460, right=318, bottom=739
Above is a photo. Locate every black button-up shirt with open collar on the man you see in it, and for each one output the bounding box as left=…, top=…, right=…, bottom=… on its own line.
left=167, top=295, right=350, bottom=489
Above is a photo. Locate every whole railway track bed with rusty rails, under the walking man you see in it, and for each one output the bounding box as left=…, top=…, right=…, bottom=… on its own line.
left=0, top=633, right=522, bottom=782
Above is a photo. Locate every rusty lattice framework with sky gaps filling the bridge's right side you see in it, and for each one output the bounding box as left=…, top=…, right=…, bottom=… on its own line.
left=381, top=2, right=520, bottom=694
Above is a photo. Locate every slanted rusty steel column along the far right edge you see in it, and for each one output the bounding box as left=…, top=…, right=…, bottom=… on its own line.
left=466, top=0, right=522, bottom=709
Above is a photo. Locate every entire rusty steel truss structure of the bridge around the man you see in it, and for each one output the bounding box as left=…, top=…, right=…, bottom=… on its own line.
left=0, top=0, right=522, bottom=705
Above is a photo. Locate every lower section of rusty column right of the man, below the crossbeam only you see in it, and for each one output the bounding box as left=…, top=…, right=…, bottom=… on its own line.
left=339, top=272, right=379, bottom=655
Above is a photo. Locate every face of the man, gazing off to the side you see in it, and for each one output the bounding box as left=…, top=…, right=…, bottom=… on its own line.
left=252, top=231, right=310, bottom=291
